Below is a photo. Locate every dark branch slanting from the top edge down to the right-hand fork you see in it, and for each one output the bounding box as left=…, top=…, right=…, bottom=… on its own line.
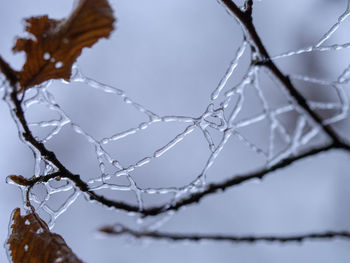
left=221, top=0, right=350, bottom=151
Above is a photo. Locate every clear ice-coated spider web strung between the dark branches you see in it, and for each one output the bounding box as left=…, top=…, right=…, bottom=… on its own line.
left=0, top=1, right=350, bottom=231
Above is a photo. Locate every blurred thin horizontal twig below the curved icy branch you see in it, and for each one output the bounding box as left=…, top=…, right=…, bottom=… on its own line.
left=99, top=225, right=350, bottom=243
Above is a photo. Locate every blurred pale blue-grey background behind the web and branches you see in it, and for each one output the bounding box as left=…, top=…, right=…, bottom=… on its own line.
left=0, top=0, right=350, bottom=263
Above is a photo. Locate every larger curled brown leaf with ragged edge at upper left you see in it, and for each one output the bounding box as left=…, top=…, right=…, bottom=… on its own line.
left=13, top=0, right=115, bottom=91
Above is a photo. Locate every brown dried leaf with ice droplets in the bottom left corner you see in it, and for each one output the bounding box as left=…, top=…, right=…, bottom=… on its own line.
left=7, top=208, right=82, bottom=263
